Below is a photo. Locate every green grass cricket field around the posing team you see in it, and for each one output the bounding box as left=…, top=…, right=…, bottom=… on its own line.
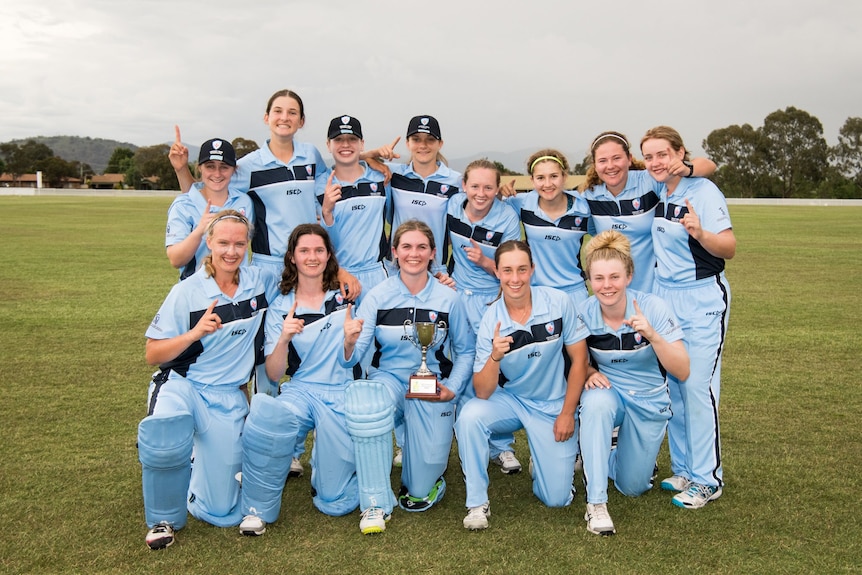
left=0, top=197, right=862, bottom=575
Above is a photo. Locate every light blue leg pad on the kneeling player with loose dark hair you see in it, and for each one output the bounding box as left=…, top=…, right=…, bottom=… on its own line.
left=242, top=393, right=299, bottom=523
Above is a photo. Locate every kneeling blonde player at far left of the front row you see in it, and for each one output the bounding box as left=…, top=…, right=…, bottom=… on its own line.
left=138, top=210, right=278, bottom=549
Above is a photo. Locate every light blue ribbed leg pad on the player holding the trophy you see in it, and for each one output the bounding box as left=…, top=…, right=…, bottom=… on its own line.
left=345, top=379, right=395, bottom=513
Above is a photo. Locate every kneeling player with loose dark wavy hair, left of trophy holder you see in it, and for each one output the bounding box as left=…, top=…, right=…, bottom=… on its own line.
left=240, top=224, right=359, bottom=535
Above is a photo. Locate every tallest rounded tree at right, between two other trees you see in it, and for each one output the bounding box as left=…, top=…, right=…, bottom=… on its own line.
left=761, top=106, right=829, bottom=198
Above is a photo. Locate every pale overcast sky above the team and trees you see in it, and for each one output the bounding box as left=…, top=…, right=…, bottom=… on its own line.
left=0, top=0, right=862, bottom=168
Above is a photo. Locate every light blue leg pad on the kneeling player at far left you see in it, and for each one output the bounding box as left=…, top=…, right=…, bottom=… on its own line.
left=138, top=413, right=195, bottom=529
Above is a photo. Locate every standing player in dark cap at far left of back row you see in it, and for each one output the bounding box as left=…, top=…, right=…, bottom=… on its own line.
left=165, top=138, right=254, bottom=280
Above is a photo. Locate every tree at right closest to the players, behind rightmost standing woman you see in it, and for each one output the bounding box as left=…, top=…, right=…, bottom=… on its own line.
left=703, top=124, right=777, bottom=198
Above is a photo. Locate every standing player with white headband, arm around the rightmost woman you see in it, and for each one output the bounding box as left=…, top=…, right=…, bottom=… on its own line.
left=583, top=131, right=715, bottom=292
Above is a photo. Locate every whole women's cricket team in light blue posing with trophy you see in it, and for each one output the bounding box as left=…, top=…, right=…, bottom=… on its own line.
left=138, top=90, right=736, bottom=549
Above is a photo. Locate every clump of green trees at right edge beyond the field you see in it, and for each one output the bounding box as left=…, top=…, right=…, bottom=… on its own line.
left=703, top=106, right=862, bottom=198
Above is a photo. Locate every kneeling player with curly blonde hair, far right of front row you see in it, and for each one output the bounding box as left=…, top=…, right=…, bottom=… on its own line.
left=579, top=230, right=689, bottom=535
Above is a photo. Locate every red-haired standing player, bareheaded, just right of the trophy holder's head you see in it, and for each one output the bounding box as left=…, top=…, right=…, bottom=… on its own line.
left=448, top=160, right=521, bottom=474
